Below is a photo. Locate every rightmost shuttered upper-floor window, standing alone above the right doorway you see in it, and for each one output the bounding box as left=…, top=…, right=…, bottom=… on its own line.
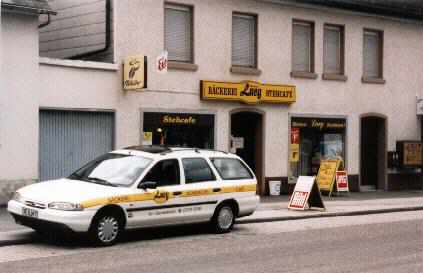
left=363, top=29, right=383, bottom=81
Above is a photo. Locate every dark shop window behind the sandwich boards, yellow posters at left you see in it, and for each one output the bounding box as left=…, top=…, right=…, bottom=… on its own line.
left=289, top=117, right=346, bottom=182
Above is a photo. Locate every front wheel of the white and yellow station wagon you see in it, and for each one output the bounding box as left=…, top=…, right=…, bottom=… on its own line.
left=90, top=214, right=122, bottom=246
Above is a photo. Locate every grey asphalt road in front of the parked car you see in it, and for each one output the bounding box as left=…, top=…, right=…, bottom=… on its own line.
left=0, top=212, right=423, bottom=273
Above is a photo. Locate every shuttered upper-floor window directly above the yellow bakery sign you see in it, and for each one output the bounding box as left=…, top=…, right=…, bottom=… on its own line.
left=232, top=13, right=257, bottom=68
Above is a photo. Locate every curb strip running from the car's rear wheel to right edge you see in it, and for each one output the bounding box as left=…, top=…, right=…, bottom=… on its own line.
left=236, top=206, right=423, bottom=225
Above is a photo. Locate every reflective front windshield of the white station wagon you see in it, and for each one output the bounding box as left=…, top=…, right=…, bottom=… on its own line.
left=68, top=153, right=153, bottom=187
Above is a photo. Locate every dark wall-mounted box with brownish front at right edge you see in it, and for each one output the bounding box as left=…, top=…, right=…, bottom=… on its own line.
left=397, top=141, right=423, bottom=168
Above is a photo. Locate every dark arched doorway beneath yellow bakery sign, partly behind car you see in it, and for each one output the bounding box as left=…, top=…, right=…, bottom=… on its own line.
left=231, top=112, right=264, bottom=194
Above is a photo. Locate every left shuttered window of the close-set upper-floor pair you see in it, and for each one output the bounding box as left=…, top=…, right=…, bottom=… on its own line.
left=292, top=20, right=314, bottom=76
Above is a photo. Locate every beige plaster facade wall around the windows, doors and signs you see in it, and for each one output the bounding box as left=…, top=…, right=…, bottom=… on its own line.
left=36, top=0, right=423, bottom=181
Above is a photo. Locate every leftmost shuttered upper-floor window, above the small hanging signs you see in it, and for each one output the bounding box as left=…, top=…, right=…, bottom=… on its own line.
left=165, top=4, right=194, bottom=63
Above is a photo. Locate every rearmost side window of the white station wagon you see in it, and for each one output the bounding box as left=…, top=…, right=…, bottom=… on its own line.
left=210, top=158, right=253, bottom=180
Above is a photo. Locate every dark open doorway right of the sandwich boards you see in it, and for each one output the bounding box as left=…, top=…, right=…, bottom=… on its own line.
left=360, top=116, right=386, bottom=190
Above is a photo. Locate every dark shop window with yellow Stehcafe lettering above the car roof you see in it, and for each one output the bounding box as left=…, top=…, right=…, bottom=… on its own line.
left=142, top=112, right=215, bottom=149
